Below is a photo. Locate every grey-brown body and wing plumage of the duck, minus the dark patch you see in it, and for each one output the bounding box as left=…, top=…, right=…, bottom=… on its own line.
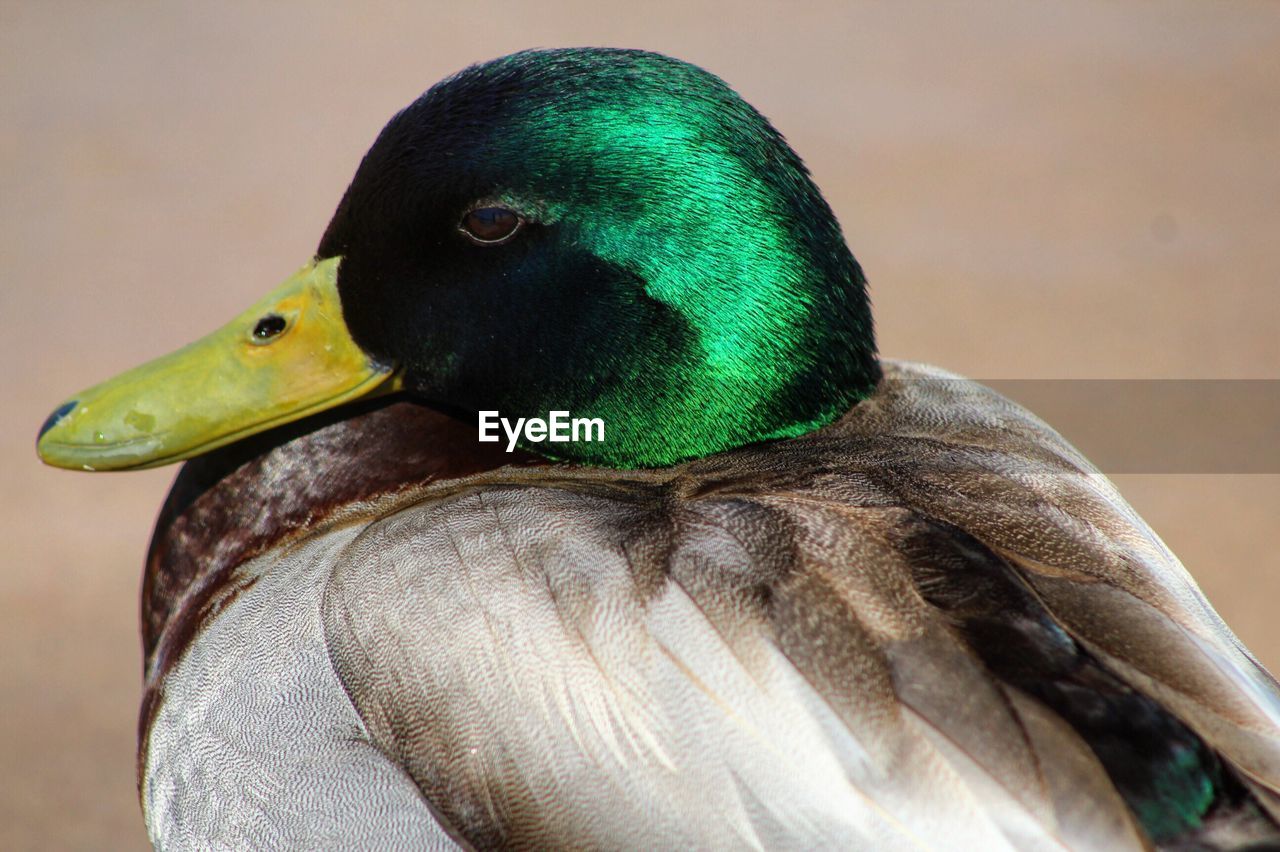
left=143, top=363, right=1280, bottom=849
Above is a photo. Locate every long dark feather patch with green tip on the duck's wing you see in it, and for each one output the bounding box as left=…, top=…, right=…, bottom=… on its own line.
left=901, top=519, right=1264, bottom=846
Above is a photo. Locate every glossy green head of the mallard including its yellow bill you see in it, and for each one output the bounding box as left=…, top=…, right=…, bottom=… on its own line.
left=37, top=49, right=879, bottom=469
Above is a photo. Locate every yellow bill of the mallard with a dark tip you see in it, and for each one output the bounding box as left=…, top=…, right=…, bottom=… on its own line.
left=36, top=257, right=398, bottom=471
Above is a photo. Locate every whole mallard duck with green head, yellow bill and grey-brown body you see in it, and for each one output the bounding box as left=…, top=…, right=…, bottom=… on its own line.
left=38, top=49, right=1280, bottom=849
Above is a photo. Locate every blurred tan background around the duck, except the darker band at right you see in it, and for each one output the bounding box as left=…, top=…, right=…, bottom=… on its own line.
left=0, top=0, right=1280, bottom=849
